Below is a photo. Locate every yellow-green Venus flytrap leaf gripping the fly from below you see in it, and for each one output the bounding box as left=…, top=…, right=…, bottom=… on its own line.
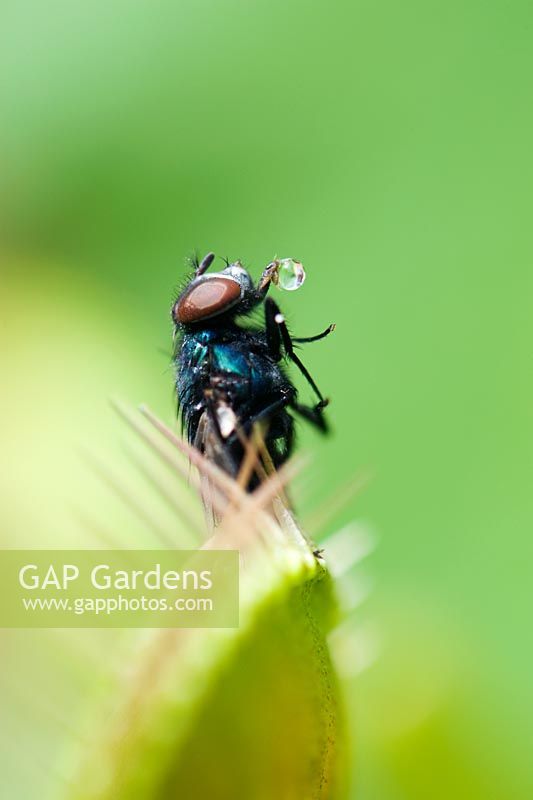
left=68, top=410, right=345, bottom=800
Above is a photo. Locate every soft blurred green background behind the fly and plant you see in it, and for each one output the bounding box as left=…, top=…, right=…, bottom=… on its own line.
left=0, top=0, right=533, bottom=800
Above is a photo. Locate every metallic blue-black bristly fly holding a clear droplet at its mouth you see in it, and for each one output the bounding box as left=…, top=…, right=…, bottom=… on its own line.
left=172, top=253, right=335, bottom=500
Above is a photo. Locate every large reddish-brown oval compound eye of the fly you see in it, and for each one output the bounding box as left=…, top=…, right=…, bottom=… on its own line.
left=172, top=276, right=241, bottom=325
